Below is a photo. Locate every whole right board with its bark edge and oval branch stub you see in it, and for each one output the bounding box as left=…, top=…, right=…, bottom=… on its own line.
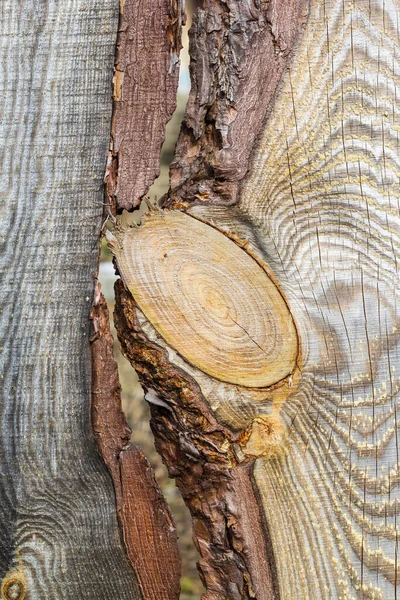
left=111, top=0, right=400, bottom=600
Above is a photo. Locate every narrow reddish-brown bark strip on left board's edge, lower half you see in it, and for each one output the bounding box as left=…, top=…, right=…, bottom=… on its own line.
left=91, top=284, right=181, bottom=600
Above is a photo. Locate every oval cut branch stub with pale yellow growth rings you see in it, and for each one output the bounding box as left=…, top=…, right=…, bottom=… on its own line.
left=110, top=210, right=298, bottom=388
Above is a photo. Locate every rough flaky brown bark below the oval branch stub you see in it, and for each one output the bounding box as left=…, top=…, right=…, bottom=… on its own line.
left=115, top=280, right=277, bottom=600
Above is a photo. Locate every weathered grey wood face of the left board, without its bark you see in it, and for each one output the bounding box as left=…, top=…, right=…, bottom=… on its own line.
left=0, top=0, right=141, bottom=600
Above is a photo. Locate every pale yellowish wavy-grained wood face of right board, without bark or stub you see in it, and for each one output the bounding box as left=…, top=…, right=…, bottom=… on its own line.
left=239, top=0, right=400, bottom=600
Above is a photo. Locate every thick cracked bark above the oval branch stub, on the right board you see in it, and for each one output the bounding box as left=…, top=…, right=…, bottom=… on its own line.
left=166, top=0, right=307, bottom=207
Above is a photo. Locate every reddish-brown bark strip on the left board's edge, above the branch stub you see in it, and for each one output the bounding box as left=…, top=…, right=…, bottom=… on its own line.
left=106, top=0, right=184, bottom=212
